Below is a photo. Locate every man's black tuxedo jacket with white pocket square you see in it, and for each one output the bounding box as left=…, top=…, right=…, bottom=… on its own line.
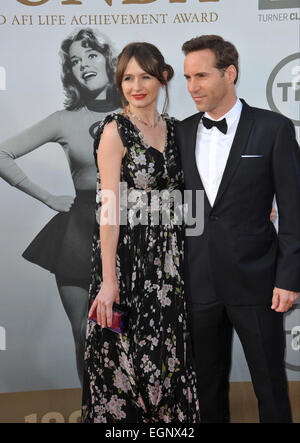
left=176, top=100, right=300, bottom=305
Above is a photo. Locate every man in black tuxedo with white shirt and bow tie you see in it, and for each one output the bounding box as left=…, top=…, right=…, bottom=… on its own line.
left=176, top=35, right=300, bottom=423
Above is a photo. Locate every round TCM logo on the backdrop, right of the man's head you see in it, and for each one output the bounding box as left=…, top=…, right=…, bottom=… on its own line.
left=267, top=52, right=300, bottom=126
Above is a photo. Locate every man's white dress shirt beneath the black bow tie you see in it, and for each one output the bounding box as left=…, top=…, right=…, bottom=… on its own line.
left=195, top=99, right=243, bottom=206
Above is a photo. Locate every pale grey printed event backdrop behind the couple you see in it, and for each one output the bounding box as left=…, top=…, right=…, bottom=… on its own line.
left=0, top=0, right=300, bottom=422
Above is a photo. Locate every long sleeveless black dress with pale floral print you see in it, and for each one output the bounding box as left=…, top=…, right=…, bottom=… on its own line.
left=82, top=114, right=199, bottom=423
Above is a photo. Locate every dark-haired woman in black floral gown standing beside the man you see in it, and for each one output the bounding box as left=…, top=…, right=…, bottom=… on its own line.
left=82, top=43, right=200, bottom=423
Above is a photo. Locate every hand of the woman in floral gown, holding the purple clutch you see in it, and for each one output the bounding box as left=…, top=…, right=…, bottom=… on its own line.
left=89, top=280, right=120, bottom=328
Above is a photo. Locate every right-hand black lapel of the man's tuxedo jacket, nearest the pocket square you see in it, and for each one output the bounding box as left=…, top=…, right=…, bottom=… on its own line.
left=214, top=100, right=253, bottom=207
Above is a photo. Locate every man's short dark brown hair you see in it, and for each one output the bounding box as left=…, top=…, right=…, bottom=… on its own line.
left=182, top=35, right=239, bottom=83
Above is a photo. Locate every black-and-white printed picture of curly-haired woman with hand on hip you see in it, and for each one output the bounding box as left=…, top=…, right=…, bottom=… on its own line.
left=0, top=28, right=121, bottom=383
